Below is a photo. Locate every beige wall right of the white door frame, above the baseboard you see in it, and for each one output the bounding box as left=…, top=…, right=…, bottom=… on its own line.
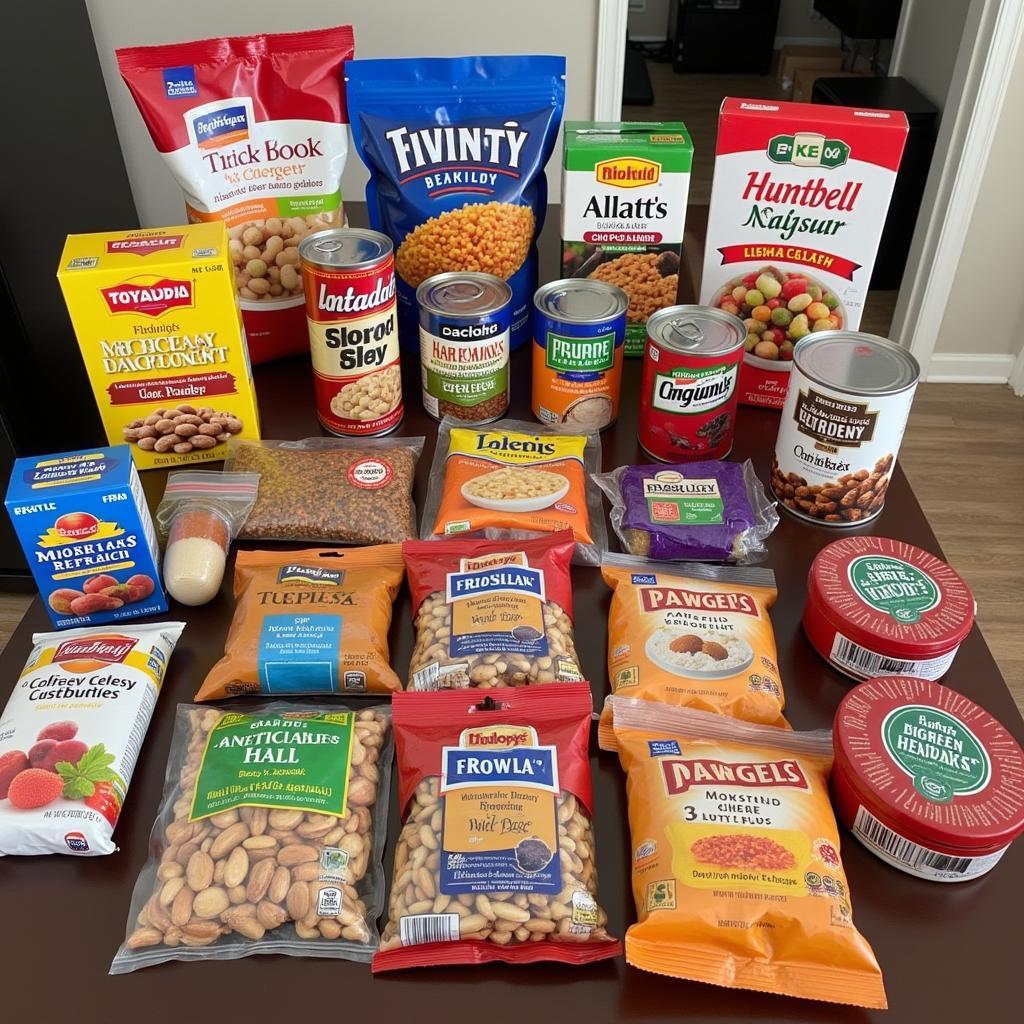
left=935, top=29, right=1024, bottom=355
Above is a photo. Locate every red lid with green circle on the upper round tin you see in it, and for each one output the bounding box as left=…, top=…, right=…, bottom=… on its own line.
left=807, top=537, right=975, bottom=662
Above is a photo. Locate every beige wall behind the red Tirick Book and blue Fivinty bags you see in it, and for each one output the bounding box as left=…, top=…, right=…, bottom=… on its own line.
left=87, top=0, right=599, bottom=225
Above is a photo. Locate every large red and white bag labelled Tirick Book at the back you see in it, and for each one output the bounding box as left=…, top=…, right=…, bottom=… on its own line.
left=117, top=25, right=354, bottom=362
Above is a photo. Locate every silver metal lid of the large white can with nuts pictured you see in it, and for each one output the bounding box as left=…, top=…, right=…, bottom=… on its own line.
left=793, top=331, right=921, bottom=394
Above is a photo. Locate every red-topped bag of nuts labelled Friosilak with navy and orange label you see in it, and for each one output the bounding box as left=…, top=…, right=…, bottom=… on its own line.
left=401, top=529, right=584, bottom=690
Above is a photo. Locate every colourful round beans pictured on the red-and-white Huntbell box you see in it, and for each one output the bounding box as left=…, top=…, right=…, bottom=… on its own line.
left=712, top=266, right=846, bottom=370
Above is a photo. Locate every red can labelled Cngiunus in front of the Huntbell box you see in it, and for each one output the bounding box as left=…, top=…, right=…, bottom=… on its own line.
left=638, top=306, right=746, bottom=462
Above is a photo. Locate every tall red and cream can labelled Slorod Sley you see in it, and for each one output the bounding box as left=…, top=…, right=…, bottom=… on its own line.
left=299, top=227, right=403, bottom=437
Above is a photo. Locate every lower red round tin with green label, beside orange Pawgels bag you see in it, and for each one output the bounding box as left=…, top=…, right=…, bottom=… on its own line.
left=833, top=676, right=1024, bottom=882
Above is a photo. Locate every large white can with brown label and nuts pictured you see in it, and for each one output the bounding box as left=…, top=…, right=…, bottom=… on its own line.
left=771, top=331, right=921, bottom=526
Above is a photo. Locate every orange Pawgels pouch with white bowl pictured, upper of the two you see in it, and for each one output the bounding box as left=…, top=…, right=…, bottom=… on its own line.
left=597, top=554, right=788, bottom=751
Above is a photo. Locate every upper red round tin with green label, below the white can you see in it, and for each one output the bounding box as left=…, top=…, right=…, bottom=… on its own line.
left=804, top=537, right=975, bottom=679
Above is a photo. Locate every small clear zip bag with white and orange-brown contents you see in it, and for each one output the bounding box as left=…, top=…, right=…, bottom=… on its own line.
left=157, top=469, right=259, bottom=605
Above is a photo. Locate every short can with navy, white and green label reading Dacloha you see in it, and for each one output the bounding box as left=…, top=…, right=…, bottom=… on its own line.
left=416, top=270, right=512, bottom=423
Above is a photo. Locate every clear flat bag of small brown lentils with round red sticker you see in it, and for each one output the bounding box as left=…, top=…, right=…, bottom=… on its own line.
left=224, top=437, right=424, bottom=544
